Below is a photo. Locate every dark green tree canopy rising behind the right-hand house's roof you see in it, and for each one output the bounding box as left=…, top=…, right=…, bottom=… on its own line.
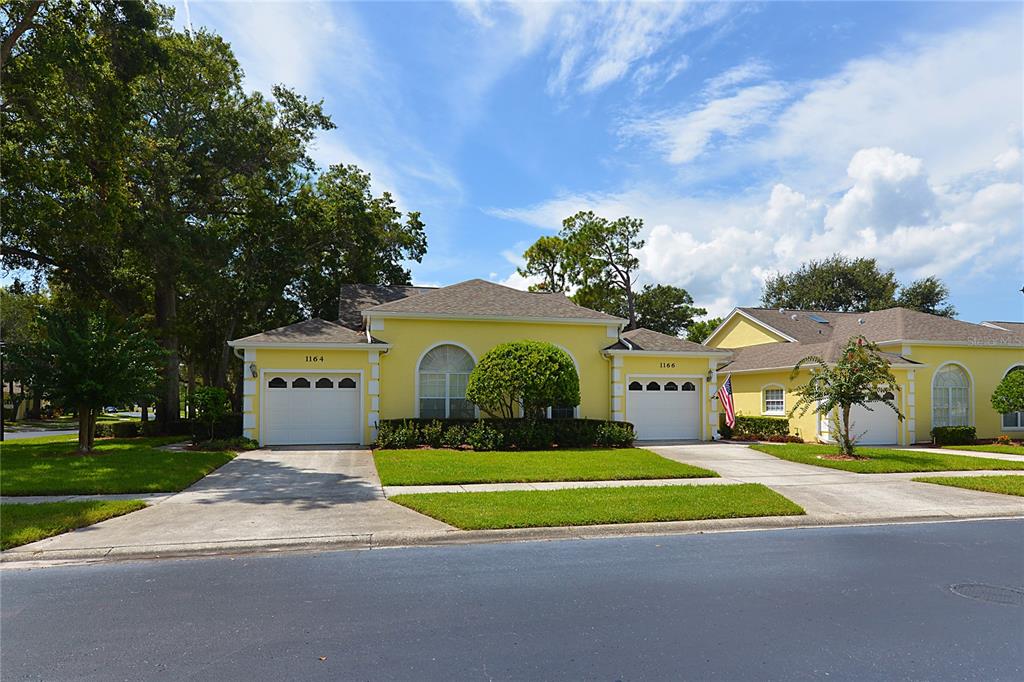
left=761, top=254, right=956, bottom=317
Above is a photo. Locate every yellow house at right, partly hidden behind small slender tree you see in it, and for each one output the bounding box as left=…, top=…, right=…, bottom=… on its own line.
left=705, top=308, right=1024, bottom=444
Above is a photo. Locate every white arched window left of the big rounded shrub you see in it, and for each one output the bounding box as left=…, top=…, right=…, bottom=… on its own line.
left=418, top=345, right=476, bottom=419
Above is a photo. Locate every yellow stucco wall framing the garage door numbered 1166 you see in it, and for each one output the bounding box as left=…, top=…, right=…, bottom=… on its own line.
left=611, top=354, right=718, bottom=440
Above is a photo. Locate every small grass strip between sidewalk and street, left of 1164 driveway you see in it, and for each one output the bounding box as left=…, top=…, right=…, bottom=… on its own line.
left=0, top=500, right=145, bottom=549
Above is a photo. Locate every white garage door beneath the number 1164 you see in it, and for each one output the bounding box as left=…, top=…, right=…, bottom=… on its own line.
left=262, top=372, right=359, bottom=445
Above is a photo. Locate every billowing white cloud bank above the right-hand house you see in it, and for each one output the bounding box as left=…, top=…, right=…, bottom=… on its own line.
left=492, top=148, right=1024, bottom=314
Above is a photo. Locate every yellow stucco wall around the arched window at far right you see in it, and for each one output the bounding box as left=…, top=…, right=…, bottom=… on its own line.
left=900, top=345, right=1024, bottom=441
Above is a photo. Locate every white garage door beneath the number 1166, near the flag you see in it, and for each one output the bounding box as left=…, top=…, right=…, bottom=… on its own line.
left=626, top=379, right=700, bottom=440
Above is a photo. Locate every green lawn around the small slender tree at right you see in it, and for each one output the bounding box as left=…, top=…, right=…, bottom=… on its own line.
left=751, top=443, right=1024, bottom=473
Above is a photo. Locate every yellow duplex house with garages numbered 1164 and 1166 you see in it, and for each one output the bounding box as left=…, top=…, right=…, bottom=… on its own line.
left=229, top=280, right=732, bottom=444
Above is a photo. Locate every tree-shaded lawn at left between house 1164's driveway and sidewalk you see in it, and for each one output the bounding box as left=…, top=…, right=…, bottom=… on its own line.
left=0, top=435, right=234, bottom=496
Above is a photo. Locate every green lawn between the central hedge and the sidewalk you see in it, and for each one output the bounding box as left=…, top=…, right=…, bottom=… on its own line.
left=374, top=447, right=718, bottom=485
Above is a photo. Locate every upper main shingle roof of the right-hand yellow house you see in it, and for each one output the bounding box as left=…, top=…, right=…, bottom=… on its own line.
left=738, top=308, right=1024, bottom=345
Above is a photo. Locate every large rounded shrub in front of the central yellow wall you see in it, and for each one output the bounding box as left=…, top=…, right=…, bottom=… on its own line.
left=466, top=341, right=580, bottom=419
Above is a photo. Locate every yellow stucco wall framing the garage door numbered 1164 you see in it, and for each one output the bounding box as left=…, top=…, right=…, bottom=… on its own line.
left=242, top=348, right=378, bottom=443
